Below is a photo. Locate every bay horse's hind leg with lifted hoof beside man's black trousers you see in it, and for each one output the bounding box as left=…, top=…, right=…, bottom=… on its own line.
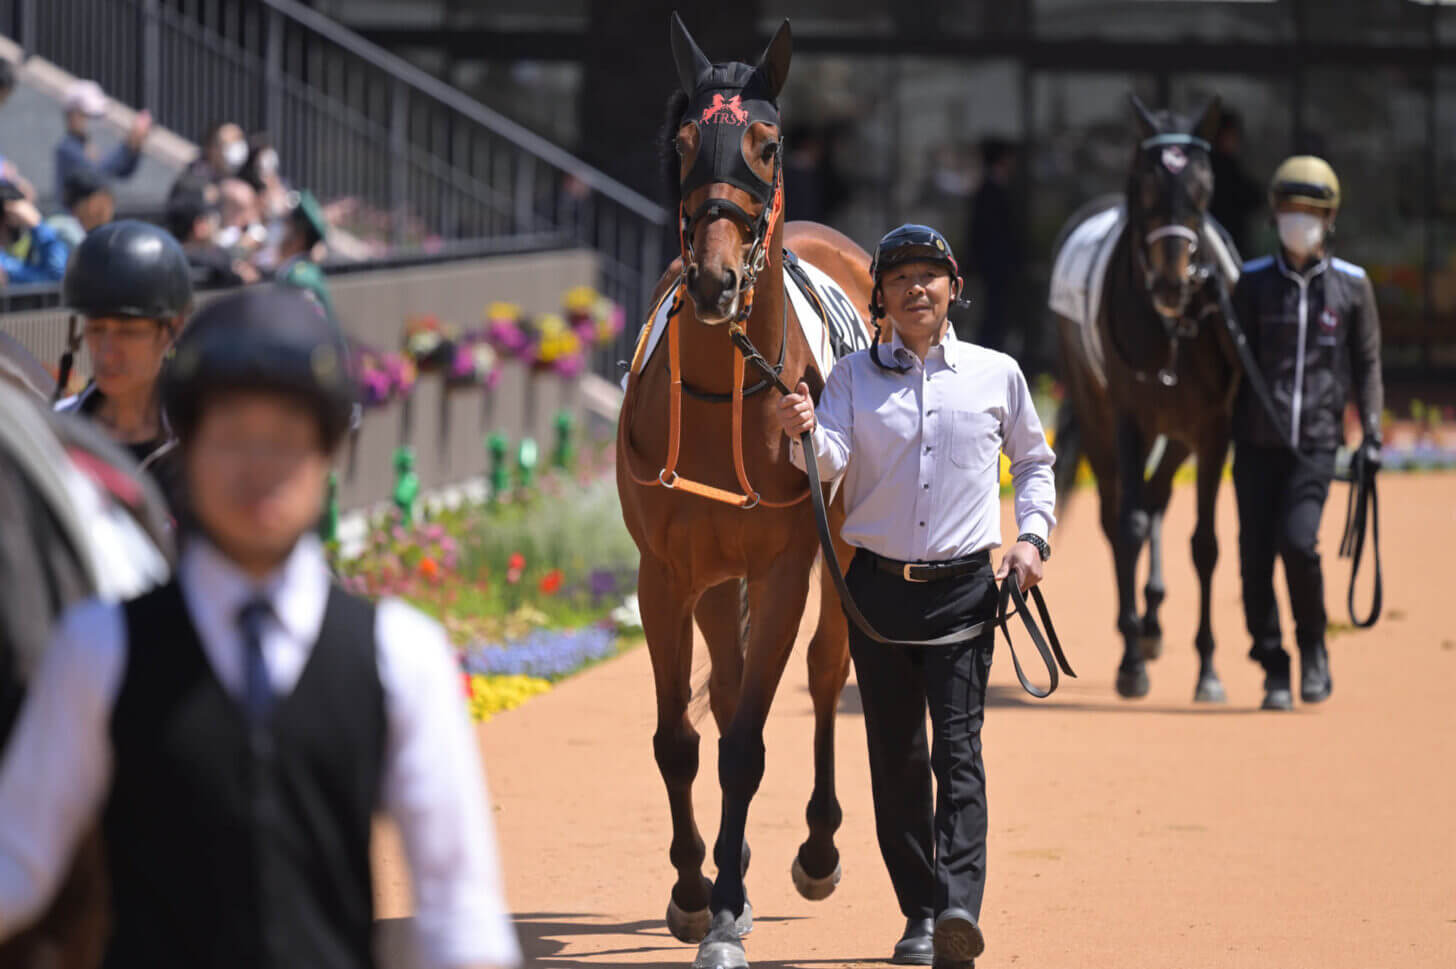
left=791, top=520, right=853, bottom=902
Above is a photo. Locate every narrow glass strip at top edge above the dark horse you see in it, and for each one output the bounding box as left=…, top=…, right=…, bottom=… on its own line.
left=1034, top=0, right=1292, bottom=44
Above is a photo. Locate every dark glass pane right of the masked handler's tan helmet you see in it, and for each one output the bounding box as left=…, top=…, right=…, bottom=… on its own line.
left=1296, top=68, right=1430, bottom=367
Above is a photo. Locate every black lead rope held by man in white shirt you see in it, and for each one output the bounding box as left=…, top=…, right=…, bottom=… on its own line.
left=729, top=329, right=1076, bottom=700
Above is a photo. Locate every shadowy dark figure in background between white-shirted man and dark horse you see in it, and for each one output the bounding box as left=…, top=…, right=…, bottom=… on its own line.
left=968, top=137, right=1022, bottom=351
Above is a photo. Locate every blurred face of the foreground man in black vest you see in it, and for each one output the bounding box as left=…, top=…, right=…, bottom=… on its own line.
left=185, top=391, right=331, bottom=570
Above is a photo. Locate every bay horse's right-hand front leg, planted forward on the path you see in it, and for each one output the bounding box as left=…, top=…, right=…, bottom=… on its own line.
left=693, top=546, right=812, bottom=969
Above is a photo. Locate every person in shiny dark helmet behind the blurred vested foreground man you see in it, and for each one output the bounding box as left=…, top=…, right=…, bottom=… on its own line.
left=55, top=220, right=192, bottom=515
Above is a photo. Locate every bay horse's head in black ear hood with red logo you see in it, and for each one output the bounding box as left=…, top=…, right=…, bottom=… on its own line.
left=673, top=13, right=792, bottom=323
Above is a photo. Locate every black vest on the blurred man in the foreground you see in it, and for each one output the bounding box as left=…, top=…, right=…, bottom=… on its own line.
left=105, top=581, right=386, bottom=969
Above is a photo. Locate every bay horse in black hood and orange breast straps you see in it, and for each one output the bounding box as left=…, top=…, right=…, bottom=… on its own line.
left=616, top=13, right=871, bottom=969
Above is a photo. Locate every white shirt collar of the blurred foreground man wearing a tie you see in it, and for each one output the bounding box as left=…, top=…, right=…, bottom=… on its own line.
left=178, top=534, right=329, bottom=643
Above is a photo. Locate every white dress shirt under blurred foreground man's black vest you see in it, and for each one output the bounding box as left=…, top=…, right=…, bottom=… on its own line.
left=0, top=535, right=521, bottom=968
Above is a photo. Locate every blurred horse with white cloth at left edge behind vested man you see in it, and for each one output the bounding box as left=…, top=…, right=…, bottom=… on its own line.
left=0, top=363, right=172, bottom=969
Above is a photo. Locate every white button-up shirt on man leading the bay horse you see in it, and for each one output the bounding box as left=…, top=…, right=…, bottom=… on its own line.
left=789, top=327, right=1057, bottom=562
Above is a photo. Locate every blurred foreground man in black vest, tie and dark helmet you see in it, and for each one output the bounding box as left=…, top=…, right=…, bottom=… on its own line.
left=0, top=287, right=521, bottom=969
